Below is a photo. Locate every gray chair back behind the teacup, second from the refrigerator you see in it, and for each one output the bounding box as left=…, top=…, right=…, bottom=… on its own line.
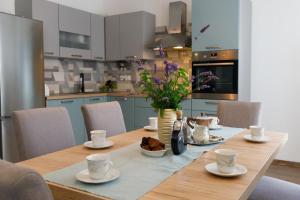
left=81, top=101, right=126, bottom=140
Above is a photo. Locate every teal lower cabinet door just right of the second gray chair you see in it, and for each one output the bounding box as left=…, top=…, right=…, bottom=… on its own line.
left=110, top=97, right=134, bottom=131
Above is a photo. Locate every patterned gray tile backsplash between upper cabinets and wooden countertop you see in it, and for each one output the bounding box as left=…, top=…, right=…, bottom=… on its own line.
left=45, top=51, right=192, bottom=94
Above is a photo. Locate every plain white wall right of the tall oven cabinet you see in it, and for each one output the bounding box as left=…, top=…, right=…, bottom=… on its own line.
left=251, top=0, right=300, bottom=162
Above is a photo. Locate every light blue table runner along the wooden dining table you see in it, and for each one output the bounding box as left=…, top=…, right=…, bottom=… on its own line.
left=44, top=127, right=243, bottom=200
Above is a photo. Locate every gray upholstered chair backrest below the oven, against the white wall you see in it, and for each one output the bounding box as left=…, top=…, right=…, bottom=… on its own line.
left=218, top=101, right=261, bottom=128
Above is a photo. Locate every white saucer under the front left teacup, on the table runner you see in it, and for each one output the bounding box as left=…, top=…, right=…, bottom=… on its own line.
left=76, top=168, right=120, bottom=184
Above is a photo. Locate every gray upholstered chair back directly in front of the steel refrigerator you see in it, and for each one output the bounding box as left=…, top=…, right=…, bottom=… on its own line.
left=12, top=107, right=75, bottom=160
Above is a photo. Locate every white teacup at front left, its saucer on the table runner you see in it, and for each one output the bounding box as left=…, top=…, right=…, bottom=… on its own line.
left=86, top=154, right=113, bottom=180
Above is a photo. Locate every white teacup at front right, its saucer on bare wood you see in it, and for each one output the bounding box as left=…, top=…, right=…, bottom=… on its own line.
left=215, top=149, right=237, bottom=174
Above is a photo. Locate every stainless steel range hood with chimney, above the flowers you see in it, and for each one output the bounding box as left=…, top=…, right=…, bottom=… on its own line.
left=151, top=1, right=191, bottom=50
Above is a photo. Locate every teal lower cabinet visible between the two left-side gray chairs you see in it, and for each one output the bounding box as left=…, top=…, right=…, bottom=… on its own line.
left=47, top=99, right=86, bottom=144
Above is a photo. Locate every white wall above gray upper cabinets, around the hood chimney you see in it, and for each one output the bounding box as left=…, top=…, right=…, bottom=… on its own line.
left=49, top=0, right=192, bottom=26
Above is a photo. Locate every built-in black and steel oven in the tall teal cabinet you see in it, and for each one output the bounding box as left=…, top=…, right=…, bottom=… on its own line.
left=192, top=50, right=238, bottom=100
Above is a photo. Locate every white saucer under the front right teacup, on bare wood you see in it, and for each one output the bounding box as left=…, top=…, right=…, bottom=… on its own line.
left=205, top=162, right=248, bottom=177
